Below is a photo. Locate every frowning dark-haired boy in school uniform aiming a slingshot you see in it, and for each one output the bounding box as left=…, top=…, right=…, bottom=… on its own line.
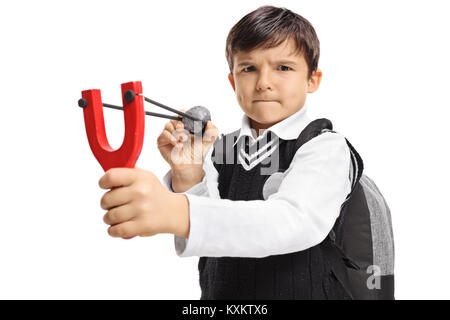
left=99, top=6, right=351, bottom=299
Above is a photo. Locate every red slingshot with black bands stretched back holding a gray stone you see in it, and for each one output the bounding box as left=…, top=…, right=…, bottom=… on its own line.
left=78, top=81, right=211, bottom=172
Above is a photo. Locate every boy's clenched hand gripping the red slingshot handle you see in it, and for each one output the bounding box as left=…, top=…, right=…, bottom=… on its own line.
left=98, top=168, right=189, bottom=239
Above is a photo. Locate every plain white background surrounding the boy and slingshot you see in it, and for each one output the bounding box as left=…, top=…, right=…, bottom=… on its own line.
left=0, top=0, right=450, bottom=299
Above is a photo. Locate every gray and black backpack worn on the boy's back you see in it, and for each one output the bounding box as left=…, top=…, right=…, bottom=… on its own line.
left=294, top=119, right=395, bottom=300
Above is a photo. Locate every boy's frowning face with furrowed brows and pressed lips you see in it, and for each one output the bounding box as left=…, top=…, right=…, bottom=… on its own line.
left=228, top=38, right=322, bottom=135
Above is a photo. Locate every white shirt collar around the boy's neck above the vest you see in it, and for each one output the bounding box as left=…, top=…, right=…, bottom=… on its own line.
left=233, top=104, right=310, bottom=147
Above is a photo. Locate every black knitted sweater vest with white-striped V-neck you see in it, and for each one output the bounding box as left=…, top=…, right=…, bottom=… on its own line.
left=198, top=122, right=349, bottom=300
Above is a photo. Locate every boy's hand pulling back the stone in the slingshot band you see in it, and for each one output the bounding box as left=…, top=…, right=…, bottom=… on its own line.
left=157, top=109, right=219, bottom=192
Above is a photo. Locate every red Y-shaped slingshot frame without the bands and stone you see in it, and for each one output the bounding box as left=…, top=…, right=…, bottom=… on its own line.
left=81, top=81, right=145, bottom=172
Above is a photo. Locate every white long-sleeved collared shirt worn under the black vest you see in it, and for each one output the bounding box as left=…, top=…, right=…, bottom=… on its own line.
left=163, top=105, right=351, bottom=258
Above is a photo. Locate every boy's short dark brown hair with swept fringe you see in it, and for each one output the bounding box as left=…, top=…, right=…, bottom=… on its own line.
left=225, top=6, right=320, bottom=79
